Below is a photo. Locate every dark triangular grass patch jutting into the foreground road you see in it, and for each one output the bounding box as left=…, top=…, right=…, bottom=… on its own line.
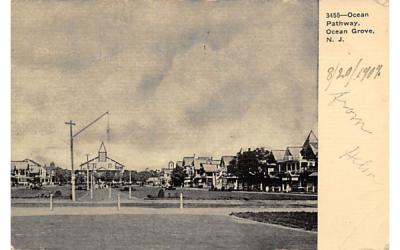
left=231, top=212, right=318, bottom=231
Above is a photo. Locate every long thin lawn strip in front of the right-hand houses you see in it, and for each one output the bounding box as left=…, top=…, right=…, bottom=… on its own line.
left=128, top=187, right=317, bottom=200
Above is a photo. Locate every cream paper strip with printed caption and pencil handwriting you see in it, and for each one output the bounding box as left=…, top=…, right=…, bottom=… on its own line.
left=318, top=0, right=389, bottom=250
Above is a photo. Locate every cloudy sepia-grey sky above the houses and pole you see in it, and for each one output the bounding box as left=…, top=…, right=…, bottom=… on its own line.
left=11, top=0, right=318, bottom=170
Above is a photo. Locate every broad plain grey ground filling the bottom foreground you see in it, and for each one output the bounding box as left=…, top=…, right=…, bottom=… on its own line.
left=11, top=214, right=317, bottom=250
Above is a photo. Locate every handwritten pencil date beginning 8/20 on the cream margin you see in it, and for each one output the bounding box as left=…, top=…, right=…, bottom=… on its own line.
left=325, top=58, right=383, bottom=91
